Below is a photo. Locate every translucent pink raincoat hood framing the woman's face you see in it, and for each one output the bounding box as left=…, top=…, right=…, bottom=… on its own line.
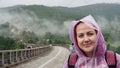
left=69, top=15, right=106, bottom=56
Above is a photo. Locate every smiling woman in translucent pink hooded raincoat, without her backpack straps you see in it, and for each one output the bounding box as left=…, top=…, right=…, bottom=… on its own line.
left=63, top=15, right=120, bottom=68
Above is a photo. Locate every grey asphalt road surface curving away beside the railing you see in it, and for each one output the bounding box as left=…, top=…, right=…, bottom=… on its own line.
left=14, top=46, right=69, bottom=68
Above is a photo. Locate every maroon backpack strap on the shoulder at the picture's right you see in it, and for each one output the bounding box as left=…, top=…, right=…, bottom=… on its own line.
left=105, top=51, right=117, bottom=68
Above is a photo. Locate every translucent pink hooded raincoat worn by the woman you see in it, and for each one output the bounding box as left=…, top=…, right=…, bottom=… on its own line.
left=63, top=15, right=120, bottom=68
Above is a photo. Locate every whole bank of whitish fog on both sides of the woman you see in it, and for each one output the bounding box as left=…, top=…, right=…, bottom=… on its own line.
left=0, top=9, right=120, bottom=39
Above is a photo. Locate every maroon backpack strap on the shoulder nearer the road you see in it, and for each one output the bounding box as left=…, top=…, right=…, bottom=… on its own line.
left=68, top=52, right=78, bottom=68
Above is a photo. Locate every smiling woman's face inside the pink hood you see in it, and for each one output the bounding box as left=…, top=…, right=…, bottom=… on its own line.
left=76, top=23, right=96, bottom=56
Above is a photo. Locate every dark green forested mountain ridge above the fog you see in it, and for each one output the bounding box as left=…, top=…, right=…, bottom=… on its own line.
left=0, top=4, right=120, bottom=21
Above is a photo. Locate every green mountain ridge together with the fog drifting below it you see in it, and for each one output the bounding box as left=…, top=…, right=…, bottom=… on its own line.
left=0, top=4, right=120, bottom=39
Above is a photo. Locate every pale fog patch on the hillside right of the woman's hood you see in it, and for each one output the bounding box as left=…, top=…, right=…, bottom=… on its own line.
left=97, top=16, right=120, bottom=40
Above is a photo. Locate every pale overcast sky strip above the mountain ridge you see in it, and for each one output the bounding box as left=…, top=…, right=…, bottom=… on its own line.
left=0, top=0, right=120, bottom=7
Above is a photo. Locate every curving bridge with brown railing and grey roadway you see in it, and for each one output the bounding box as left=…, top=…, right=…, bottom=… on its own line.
left=0, top=46, right=69, bottom=68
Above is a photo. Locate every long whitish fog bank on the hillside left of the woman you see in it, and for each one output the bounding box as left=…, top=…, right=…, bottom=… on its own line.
left=0, top=9, right=69, bottom=35
